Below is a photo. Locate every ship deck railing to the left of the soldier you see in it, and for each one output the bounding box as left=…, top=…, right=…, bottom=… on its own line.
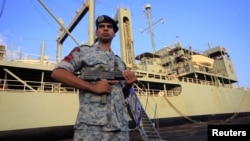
left=0, top=79, right=78, bottom=93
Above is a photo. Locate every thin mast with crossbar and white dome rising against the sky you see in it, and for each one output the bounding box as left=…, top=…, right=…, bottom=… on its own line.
left=141, top=4, right=164, bottom=53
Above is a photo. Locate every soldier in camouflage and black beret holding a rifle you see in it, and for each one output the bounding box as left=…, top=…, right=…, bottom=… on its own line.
left=51, top=15, right=136, bottom=141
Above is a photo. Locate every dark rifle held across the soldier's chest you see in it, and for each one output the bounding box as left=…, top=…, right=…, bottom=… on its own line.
left=80, top=70, right=124, bottom=104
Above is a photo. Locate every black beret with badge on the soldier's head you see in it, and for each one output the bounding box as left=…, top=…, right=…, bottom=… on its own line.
left=95, top=15, right=119, bottom=33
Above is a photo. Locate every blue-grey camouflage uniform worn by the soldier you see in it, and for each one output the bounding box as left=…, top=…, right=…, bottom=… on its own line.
left=56, top=46, right=129, bottom=141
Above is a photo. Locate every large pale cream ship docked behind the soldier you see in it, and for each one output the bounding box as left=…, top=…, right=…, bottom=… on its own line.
left=0, top=0, right=250, bottom=140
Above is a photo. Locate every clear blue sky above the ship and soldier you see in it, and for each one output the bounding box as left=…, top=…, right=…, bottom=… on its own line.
left=0, top=0, right=250, bottom=87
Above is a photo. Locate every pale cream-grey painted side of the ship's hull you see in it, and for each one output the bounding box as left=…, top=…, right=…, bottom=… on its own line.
left=0, top=82, right=250, bottom=138
